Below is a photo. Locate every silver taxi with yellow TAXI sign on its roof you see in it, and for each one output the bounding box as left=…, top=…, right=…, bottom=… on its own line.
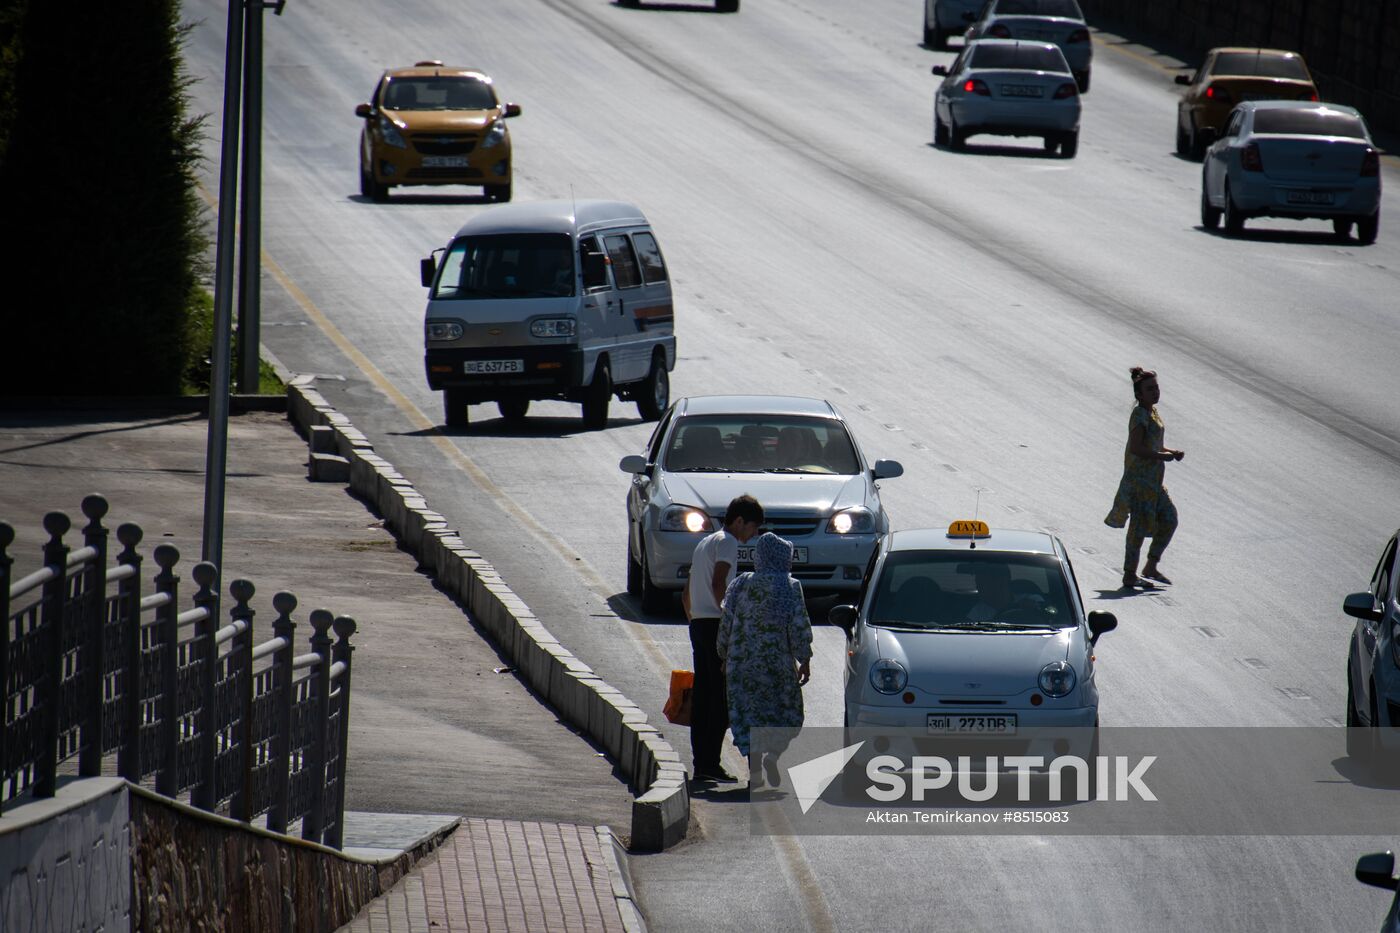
left=829, top=520, right=1117, bottom=751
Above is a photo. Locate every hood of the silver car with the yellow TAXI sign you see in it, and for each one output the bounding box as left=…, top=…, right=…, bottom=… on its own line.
left=871, top=628, right=1084, bottom=698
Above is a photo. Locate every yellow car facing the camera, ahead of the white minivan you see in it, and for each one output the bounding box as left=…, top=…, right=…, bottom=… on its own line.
left=354, top=60, right=521, bottom=202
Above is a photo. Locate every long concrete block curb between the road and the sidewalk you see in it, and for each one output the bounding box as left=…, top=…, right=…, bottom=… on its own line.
left=287, top=375, right=690, bottom=852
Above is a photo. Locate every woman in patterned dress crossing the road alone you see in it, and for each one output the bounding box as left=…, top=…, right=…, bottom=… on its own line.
left=1103, top=366, right=1186, bottom=588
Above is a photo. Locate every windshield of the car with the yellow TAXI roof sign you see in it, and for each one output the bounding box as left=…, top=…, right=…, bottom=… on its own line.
left=869, top=549, right=1078, bottom=632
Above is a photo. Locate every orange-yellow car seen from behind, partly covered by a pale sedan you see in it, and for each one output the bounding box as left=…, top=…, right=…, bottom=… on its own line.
left=1176, top=48, right=1317, bottom=160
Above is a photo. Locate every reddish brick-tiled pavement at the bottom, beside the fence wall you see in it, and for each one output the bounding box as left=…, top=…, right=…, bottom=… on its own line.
left=342, top=818, right=644, bottom=933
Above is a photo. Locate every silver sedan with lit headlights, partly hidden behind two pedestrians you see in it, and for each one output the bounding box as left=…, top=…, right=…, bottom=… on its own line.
left=619, top=395, right=904, bottom=611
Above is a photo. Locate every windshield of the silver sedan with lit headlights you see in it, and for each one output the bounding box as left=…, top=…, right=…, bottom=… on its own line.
left=664, top=415, right=860, bottom=476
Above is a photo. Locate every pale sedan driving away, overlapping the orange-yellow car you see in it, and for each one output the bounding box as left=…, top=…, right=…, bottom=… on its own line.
left=1201, top=101, right=1380, bottom=244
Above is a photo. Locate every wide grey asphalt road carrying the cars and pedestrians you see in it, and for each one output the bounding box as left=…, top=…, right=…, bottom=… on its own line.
left=185, top=0, right=1400, bottom=930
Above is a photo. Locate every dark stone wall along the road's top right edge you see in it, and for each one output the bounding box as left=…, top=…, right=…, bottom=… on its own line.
left=1079, top=0, right=1400, bottom=133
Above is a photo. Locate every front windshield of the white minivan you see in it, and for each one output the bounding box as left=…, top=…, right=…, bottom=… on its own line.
left=433, top=234, right=577, bottom=300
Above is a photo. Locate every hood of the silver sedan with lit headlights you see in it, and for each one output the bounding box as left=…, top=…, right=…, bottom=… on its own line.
left=665, top=474, right=865, bottom=516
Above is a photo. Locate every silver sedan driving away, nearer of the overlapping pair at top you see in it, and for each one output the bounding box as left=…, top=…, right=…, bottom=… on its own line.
left=934, top=39, right=1079, bottom=158
